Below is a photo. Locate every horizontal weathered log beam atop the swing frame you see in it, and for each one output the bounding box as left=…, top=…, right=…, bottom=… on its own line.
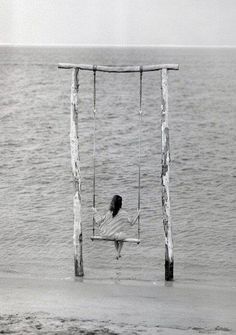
left=58, top=63, right=179, bottom=73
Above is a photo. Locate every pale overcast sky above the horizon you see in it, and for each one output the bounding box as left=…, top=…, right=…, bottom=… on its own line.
left=0, top=0, right=236, bottom=46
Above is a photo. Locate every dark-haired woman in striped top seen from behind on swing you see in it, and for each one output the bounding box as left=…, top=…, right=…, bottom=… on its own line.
left=93, top=195, right=140, bottom=259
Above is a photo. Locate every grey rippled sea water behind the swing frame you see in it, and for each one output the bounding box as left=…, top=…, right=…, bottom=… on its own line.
left=0, top=47, right=236, bottom=286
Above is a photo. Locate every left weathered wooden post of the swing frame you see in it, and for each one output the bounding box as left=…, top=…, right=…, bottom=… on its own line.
left=70, top=69, right=84, bottom=277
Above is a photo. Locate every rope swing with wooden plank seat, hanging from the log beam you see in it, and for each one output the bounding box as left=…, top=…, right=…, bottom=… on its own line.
left=91, top=66, right=143, bottom=244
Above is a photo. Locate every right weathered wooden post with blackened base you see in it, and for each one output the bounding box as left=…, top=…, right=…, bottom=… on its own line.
left=161, top=69, right=174, bottom=281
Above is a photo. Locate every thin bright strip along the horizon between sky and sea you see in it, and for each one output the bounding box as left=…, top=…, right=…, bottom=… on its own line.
left=0, top=43, right=236, bottom=48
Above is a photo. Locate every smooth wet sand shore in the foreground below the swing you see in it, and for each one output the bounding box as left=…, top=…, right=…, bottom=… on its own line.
left=0, top=278, right=236, bottom=334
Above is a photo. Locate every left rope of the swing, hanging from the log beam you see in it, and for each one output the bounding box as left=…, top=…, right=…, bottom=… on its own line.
left=93, top=65, right=97, bottom=236
